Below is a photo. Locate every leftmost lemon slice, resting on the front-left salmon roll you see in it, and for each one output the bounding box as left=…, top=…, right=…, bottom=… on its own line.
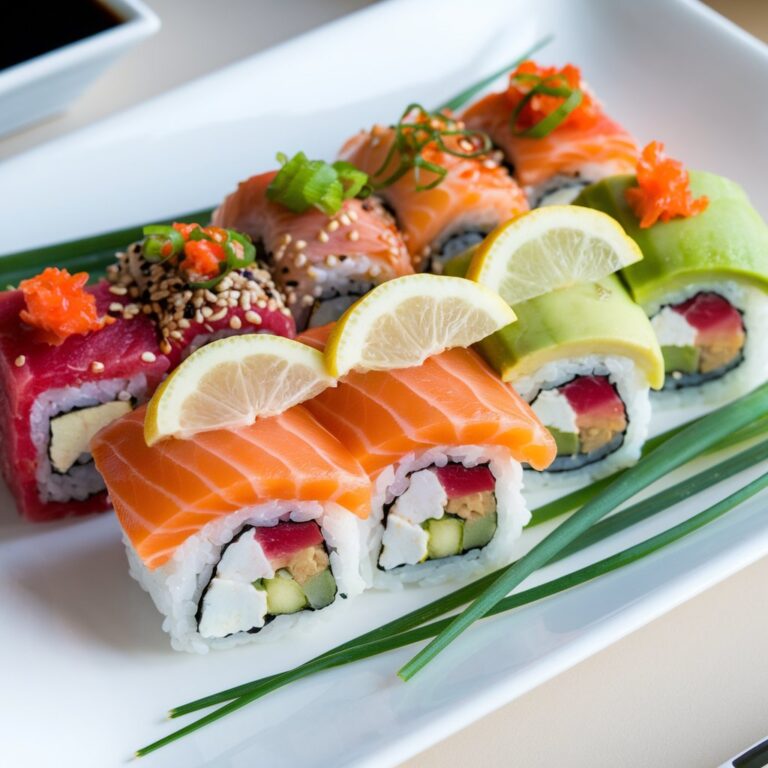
left=144, top=333, right=335, bottom=445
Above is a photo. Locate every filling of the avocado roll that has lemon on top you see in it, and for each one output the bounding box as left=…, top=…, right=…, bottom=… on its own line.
left=531, top=376, right=627, bottom=472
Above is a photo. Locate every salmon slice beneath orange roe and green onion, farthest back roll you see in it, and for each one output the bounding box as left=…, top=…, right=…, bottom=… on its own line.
left=464, top=91, right=639, bottom=187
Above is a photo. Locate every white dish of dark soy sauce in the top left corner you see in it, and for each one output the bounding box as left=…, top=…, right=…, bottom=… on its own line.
left=0, top=0, right=160, bottom=136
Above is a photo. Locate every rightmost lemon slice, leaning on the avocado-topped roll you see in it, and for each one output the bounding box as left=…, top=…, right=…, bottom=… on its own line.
left=467, top=210, right=643, bottom=305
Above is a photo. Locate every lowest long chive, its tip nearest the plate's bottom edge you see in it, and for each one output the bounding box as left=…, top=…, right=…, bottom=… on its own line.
left=136, top=473, right=768, bottom=757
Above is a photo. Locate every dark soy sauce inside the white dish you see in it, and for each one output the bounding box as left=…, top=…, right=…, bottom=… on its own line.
left=0, top=0, right=124, bottom=70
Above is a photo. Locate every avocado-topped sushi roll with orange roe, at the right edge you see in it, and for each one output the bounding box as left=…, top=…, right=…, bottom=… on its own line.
left=576, top=142, right=768, bottom=408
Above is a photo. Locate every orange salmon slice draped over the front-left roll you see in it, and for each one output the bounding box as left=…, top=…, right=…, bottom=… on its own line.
left=91, top=406, right=371, bottom=569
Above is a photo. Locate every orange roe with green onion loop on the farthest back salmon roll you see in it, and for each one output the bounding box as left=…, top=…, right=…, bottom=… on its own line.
left=506, top=61, right=600, bottom=131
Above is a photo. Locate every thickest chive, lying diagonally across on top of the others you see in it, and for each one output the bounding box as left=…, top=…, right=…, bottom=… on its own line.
left=398, top=384, right=768, bottom=680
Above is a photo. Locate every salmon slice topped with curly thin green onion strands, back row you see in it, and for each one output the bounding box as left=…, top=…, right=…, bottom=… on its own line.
left=340, top=120, right=528, bottom=269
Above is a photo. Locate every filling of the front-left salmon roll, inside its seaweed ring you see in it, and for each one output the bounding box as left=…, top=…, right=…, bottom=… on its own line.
left=197, top=521, right=337, bottom=639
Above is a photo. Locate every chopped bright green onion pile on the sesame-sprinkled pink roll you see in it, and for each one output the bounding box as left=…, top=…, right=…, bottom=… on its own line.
left=267, top=152, right=371, bottom=216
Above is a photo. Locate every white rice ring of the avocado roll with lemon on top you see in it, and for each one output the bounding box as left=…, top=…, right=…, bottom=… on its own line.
left=514, top=355, right=651, bottom=490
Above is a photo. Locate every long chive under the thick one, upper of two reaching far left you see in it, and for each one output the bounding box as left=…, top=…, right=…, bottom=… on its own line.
left=170, top=440, right=768, bottom=717
